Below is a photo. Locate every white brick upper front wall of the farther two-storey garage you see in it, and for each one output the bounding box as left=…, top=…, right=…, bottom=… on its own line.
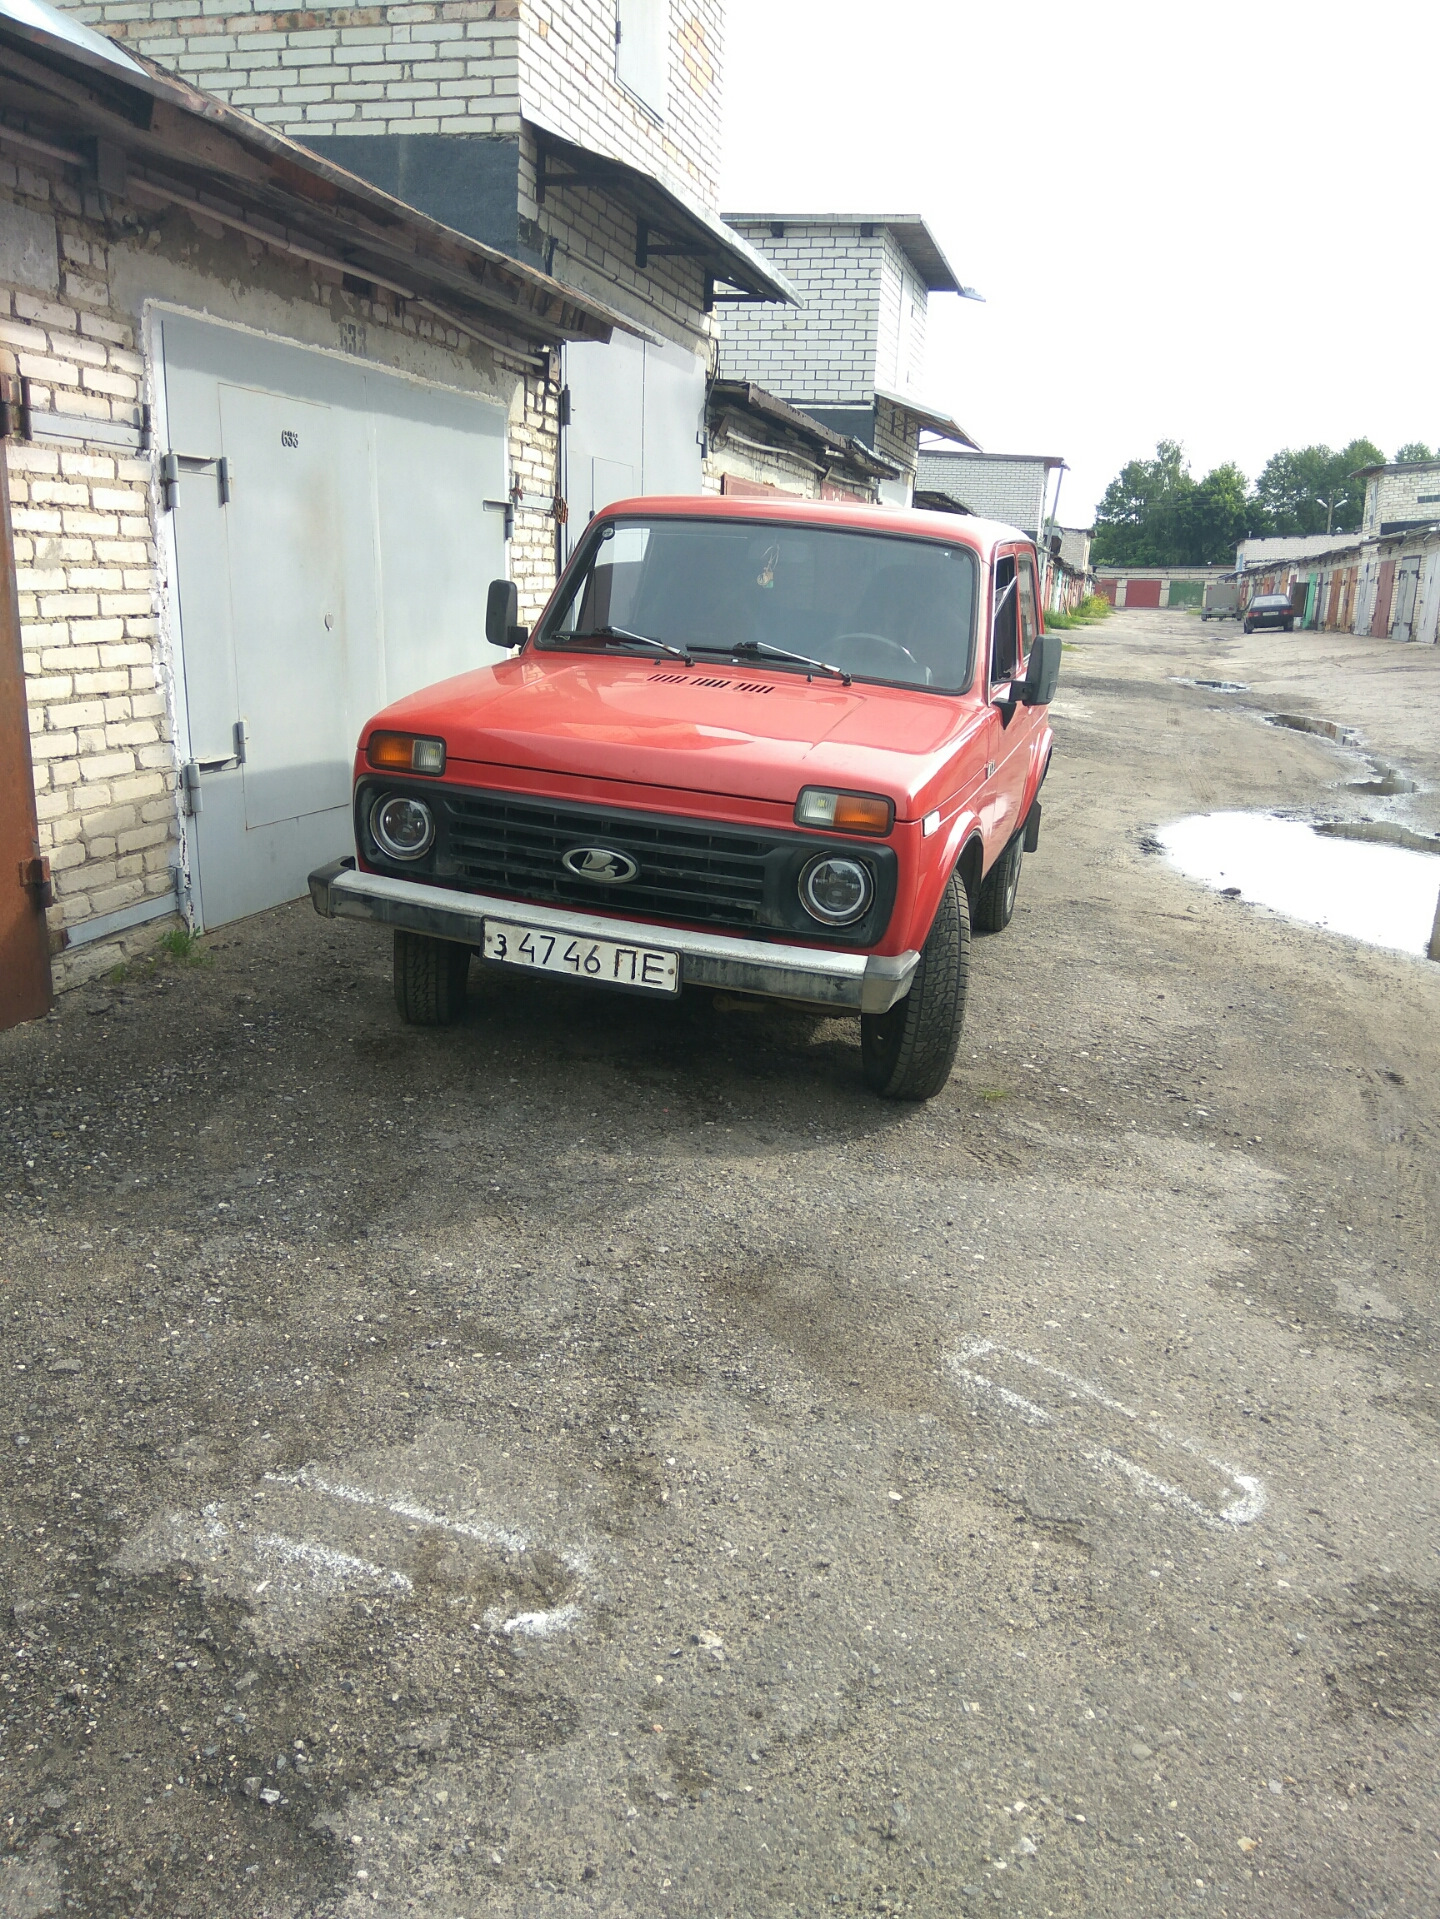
left=720, top=223, right=887, bottom=407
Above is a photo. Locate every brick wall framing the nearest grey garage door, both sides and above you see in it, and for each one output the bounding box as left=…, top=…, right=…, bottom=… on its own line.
left=0, top=144, right=557, bottom=984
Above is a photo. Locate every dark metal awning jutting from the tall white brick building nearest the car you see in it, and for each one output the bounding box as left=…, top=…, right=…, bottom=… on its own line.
left=530, top=119, right=803, bottom=313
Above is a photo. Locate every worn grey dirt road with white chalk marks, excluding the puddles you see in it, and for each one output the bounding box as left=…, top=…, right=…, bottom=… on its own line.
left=0, top=614, right=1440, bottom=1919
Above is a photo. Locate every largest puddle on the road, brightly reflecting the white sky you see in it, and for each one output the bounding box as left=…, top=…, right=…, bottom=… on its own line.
left=1156, top=814, right=1440, bottom=956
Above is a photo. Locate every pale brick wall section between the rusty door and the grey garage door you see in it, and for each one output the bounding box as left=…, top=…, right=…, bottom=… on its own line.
left=0, top=150, right=177, bottom=983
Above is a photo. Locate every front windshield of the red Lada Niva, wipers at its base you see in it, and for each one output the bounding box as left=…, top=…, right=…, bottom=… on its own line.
left=536, top=516, right=977, bottom=693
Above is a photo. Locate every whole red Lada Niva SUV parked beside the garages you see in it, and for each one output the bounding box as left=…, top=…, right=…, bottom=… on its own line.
left=309, top=497, right=1060, bottom=1100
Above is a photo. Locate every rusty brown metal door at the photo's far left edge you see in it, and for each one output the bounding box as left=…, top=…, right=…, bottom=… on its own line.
left=0, top=374, right=50, bottom=1029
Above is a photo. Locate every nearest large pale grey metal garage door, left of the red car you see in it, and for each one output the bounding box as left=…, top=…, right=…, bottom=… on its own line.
left=161, top=315, right=507, bottom=927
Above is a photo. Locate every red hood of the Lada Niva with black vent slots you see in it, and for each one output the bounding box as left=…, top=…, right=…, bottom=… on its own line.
left=367, top=649, right=979, bottom=819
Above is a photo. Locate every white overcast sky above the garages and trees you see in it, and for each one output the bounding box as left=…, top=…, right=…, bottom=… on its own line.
left=720, top=0, right=1440, bottom=526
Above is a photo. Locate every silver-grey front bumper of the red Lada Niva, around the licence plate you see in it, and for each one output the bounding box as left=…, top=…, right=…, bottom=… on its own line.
left=309, top=860, right=920, bottom=1013
